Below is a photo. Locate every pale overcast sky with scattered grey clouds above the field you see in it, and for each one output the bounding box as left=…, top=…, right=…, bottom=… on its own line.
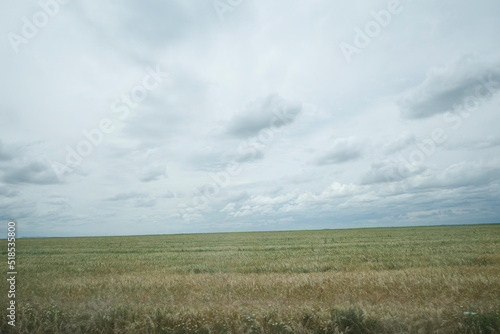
left=0, top=0, right=500, bottom=237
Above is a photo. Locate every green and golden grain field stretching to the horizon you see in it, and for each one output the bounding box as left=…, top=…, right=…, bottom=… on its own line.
left=0, top=225, right=500, bottom=333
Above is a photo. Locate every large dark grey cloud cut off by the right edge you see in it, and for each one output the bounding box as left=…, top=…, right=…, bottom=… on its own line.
left=399, top=55, right=500, bottom=119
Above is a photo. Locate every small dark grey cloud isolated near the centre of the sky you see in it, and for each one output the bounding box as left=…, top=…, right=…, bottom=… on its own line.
left=227, top=94, right=302, bottom=138
